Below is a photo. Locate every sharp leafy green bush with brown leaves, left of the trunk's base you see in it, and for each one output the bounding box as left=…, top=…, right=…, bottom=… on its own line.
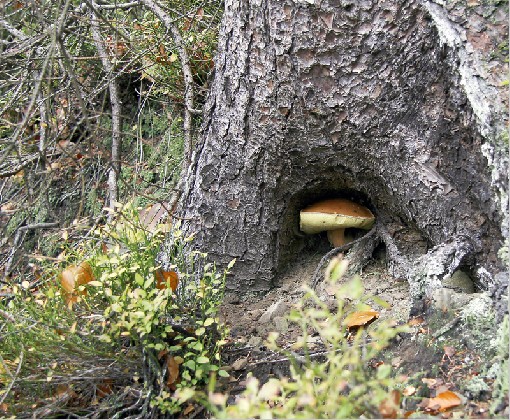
left=0, top=205, right=228, bottom=417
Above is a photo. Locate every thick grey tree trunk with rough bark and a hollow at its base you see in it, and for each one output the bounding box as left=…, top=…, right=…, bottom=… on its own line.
left=174, top=0, right=508, bottom=297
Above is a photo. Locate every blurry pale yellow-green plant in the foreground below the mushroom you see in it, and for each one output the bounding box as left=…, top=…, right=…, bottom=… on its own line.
left=199, top=259, right=405, bottom=418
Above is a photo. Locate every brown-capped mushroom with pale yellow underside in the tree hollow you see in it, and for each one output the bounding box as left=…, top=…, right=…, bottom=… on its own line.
left=299, top=198, right=375, bottom=247
